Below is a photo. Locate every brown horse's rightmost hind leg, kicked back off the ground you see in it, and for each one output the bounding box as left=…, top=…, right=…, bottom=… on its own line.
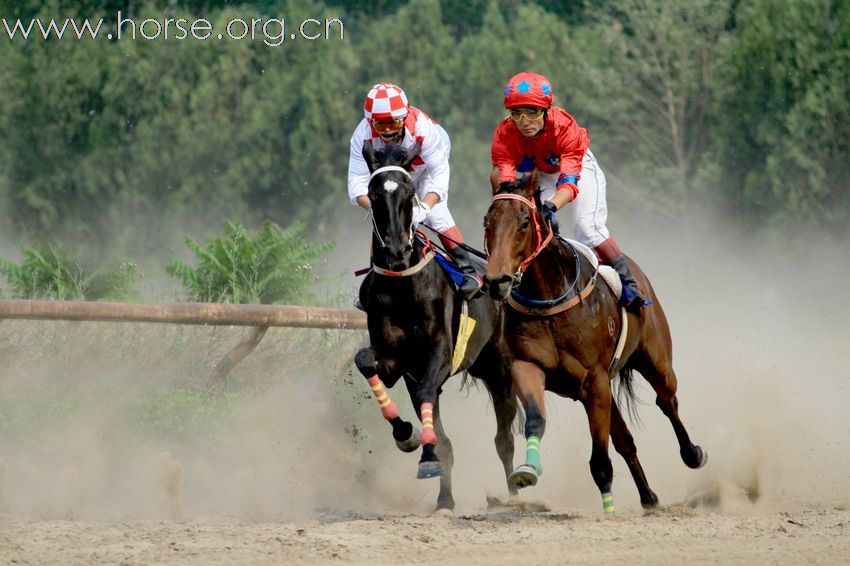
left=633, top=353, right=708, bottom=470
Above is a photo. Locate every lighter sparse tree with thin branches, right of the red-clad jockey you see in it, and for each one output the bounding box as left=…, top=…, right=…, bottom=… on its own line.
left=567, top=0, right=730, bottom=222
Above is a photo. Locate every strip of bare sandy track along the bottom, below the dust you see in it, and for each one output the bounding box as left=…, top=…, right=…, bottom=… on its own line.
left=0, top=508, right=850, bottom=564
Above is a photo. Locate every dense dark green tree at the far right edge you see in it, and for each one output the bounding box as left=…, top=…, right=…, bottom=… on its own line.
left=714, top=0, right=850, bottom=230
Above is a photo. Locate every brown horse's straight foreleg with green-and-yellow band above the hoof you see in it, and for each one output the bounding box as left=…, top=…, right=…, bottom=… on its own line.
left=581, top=370, right=614, bottom=517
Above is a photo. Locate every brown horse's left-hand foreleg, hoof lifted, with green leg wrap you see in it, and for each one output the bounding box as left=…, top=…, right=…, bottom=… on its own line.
left=508, top=360, right=546, bottom=488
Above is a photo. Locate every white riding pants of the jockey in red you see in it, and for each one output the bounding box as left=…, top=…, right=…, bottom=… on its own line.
left=537, top=149, right=610, bottom=248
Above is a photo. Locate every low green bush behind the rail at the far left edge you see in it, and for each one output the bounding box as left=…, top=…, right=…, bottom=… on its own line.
left=0, top=243, right=140, bottom=301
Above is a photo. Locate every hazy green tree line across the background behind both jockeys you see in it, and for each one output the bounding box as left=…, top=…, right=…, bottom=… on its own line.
left=0, top=0, right=850, bottom=250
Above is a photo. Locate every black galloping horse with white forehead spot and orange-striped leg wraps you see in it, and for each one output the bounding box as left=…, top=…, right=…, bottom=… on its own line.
left=355, top=142, right=517, bottom=509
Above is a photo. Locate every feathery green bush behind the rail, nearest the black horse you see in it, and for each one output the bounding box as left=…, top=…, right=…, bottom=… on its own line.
left=166, top=221, right=333, bottom=304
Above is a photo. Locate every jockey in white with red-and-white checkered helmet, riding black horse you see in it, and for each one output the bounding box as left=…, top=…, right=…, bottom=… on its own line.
left=348, top=83, right=482, bottom=299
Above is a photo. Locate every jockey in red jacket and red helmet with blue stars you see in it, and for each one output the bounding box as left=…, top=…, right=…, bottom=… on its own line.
left=490, top=73, right=647, bottom=312
